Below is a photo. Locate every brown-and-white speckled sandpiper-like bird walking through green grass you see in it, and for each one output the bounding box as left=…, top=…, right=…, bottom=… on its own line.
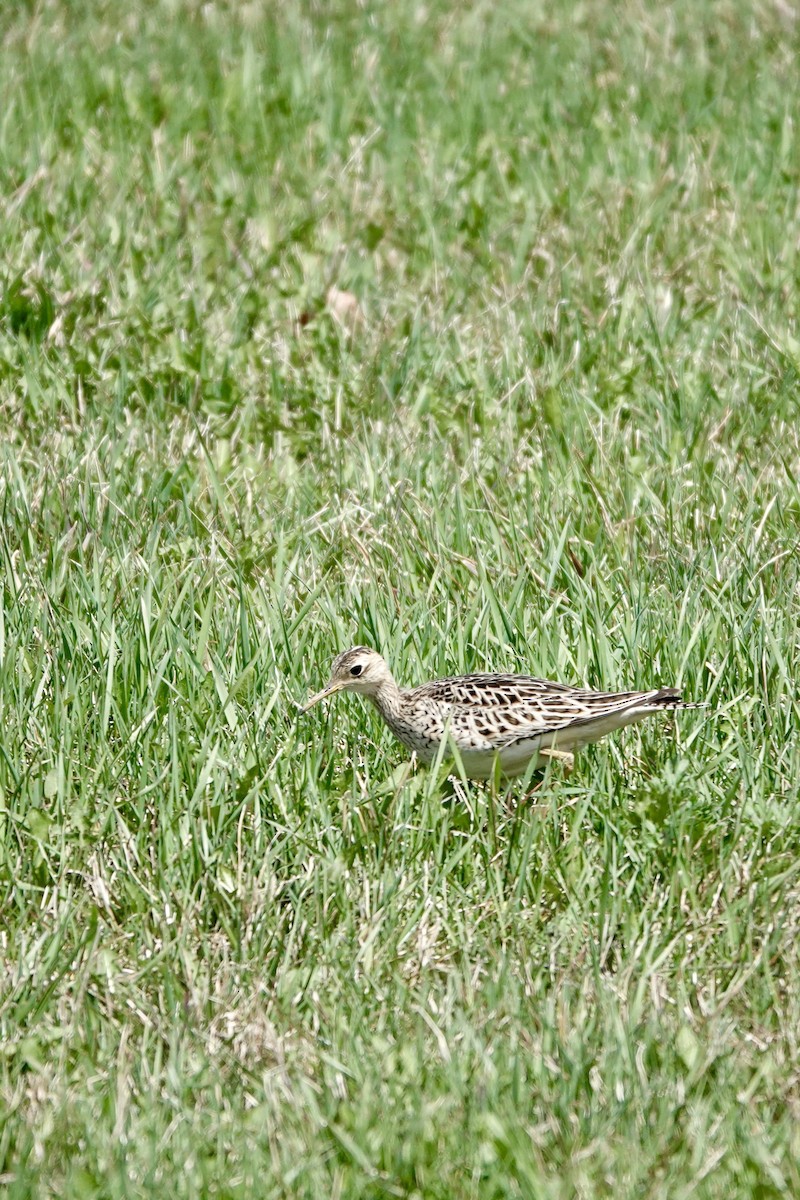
left=300, top=646, right=697, bottom=779
